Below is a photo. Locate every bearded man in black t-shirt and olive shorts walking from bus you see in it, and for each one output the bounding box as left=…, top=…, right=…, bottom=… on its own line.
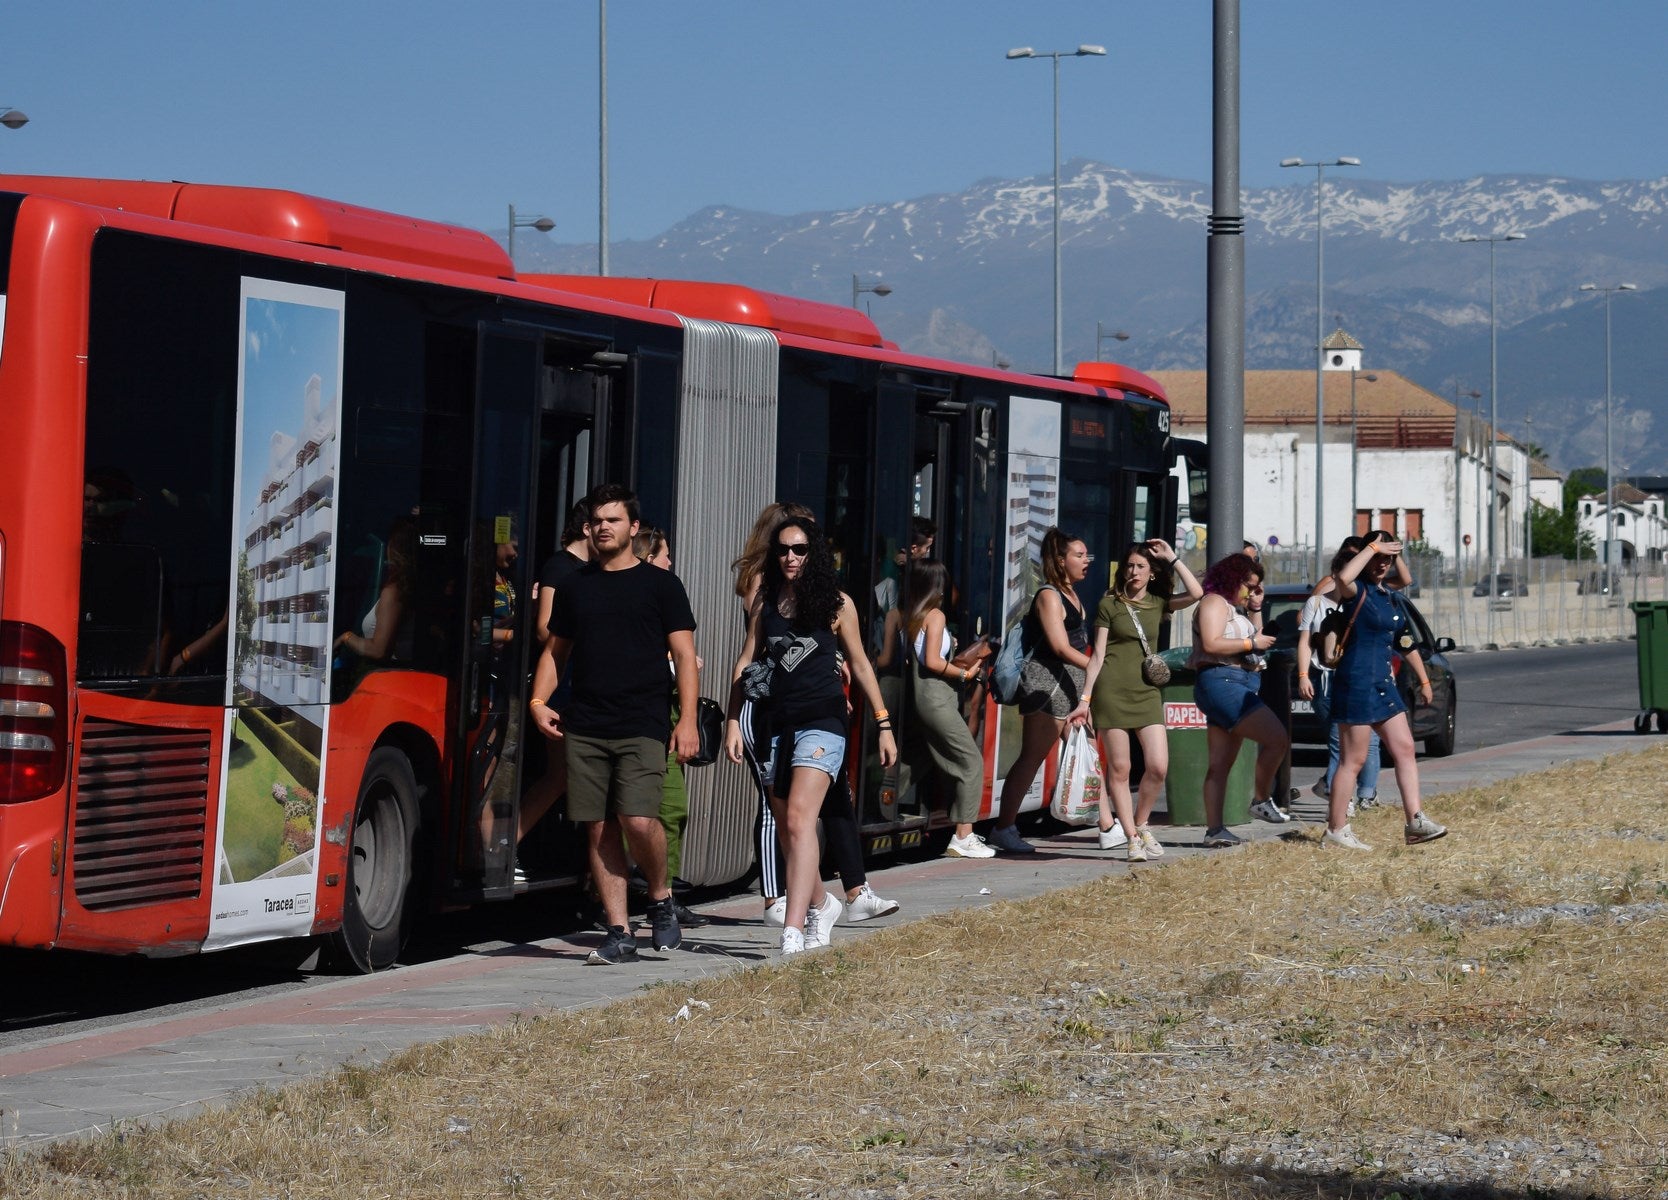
left=529, top=484, right=701, bottom=963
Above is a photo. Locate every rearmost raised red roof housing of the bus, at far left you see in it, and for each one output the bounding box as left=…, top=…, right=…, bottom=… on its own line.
left=0, top=175, right=514, bottom=279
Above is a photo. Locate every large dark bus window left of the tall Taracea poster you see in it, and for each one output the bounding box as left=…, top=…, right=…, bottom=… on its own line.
left=75, top=230, right=239, bottom=704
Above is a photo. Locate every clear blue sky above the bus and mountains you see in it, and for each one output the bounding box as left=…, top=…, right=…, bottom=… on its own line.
left=0, top=0, right=1668, bottom=242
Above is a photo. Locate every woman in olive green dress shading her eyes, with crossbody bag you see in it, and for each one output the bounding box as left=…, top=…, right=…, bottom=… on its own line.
left=1073, top=537, right=1204, bottom=863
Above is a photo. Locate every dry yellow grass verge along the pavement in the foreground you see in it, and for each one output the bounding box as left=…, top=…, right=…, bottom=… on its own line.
left=0, top=751, right=1668, bottom=1198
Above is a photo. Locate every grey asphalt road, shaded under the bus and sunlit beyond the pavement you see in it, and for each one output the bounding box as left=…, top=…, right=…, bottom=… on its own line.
left=0, top=641, right=1638, bottom=1046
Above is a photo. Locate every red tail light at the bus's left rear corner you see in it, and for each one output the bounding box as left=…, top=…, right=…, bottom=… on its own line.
left=0, top=621, right=70, bottom=804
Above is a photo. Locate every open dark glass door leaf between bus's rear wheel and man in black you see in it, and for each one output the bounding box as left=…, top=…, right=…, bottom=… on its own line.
left=447, top=325, right=542, bottom=898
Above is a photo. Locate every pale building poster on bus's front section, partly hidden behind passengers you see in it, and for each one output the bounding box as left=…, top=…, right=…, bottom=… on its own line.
left=991, top=396, right=1061, bottom=809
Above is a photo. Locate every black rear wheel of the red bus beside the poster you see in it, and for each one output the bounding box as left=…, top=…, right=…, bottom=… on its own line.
left=330, top=746, right=419, bottom=973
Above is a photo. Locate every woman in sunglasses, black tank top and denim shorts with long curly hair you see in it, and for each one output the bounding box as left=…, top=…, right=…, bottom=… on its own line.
left=724, top=517, right=897, bottom=955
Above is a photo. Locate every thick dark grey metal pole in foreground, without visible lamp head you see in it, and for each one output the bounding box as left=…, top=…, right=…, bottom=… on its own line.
left=1204, top=0, right=1246, bottom=551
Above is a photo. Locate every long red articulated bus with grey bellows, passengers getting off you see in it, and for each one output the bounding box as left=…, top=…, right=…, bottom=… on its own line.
left=0, top=175, right=1178, bottom=970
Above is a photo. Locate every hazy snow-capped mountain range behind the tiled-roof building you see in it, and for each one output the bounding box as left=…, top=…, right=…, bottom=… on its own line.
left=522, top=160, right=1668, bottom=472
